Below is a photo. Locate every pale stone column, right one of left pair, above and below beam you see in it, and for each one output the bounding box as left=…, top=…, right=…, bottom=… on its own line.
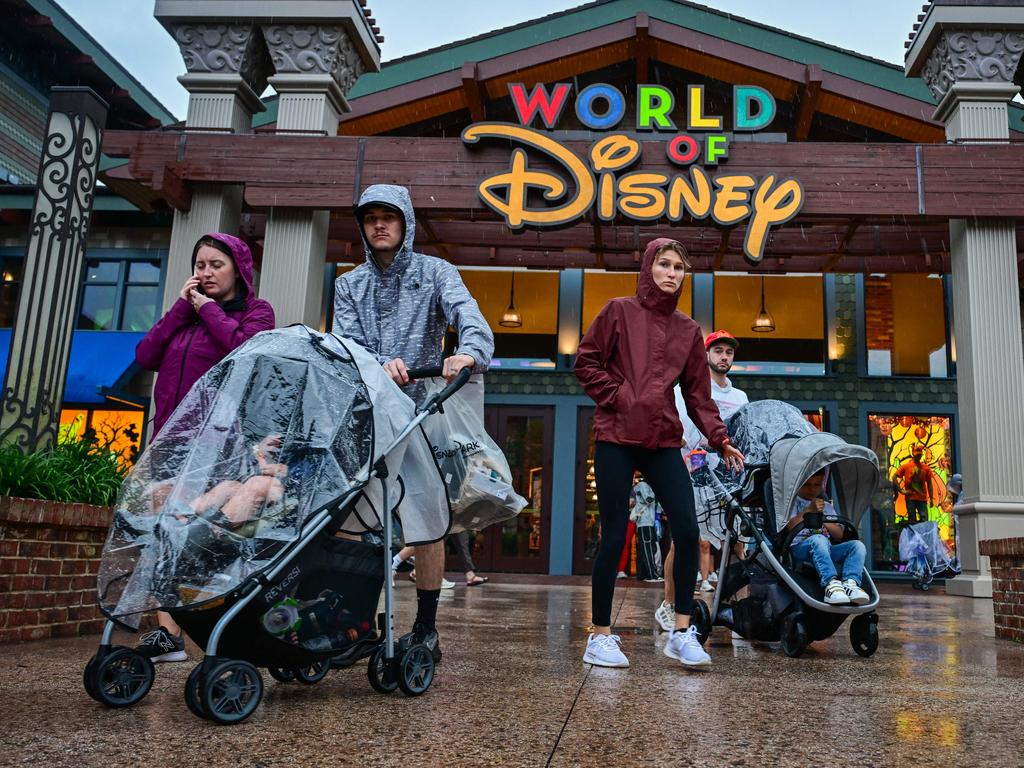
left=260, top=23, right=366, bottom=327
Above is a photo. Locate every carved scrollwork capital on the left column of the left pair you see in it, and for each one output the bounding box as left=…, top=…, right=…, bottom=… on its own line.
left=173, top=24, right=272, bottom=93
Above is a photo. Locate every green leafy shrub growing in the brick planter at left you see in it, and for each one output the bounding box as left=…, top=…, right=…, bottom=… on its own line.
left=0, top=431, right=128, bottom=507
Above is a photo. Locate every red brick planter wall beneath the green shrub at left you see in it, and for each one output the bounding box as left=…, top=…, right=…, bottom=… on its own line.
left=0, top=497, right=112, bottom=643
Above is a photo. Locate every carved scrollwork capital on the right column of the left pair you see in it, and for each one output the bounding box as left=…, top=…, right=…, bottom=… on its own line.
left=263, top=25, right=366, bottom=93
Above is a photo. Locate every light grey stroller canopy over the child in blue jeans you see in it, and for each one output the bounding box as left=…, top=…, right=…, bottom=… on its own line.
left=770, top=432, right=879, bottom=530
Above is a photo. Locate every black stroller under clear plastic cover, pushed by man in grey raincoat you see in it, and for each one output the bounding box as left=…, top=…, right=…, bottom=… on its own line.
left=84, top=326, right=499, bottom=723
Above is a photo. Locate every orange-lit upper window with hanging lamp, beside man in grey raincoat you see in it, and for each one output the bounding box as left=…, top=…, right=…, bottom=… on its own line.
left=459, top=268, right=558, bottom=369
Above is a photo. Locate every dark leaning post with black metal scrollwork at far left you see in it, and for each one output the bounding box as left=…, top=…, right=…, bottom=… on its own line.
left=0, top=88, right=108, bottom=452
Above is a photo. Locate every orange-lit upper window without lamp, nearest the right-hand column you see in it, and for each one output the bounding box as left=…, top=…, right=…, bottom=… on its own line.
left=864, top=274, right=949, bottom=378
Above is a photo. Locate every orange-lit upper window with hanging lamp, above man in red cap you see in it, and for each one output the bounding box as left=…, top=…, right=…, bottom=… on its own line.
left=715, top=274, right=826, bottom=376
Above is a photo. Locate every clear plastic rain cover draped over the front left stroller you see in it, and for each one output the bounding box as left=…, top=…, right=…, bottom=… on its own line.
left=97, top=326, right=450, bottom=626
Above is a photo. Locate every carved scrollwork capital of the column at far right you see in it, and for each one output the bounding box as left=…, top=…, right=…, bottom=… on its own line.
left=921, top=30, right=1024, bottom=101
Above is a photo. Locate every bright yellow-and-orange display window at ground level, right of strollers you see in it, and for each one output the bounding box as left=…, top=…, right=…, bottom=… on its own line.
left=861, top=414, right=955, bottom=571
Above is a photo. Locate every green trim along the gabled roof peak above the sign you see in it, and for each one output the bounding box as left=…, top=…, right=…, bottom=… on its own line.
left=342, top=0, right=1024, bottom=130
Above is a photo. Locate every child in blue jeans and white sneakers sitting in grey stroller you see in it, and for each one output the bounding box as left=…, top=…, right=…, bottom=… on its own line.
left=786, top=469, right=870, bottom=605
